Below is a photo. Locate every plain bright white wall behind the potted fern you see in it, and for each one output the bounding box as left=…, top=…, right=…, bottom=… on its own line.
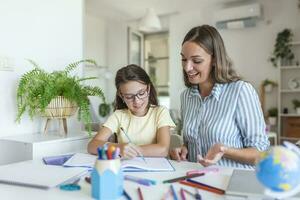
left=0, top=0, right=84, bottom=136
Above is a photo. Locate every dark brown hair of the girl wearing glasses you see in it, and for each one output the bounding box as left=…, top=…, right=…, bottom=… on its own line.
left=114, top=64, right=158, bottom=110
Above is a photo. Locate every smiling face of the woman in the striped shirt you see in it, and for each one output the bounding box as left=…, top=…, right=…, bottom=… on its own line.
left=181, top=41, right=212, bottom=85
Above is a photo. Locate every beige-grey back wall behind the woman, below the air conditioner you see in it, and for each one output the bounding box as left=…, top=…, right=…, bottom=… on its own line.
left=170, top=0, right=300, bottom=111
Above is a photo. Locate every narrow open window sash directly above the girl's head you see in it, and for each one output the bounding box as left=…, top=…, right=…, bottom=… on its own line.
left=128, top=27, right=144, bottom=68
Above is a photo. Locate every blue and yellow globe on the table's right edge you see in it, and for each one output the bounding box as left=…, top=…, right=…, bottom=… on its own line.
left=256, top=142, right=300, bottom=199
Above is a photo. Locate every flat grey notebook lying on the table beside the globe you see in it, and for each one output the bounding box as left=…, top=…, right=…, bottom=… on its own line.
left=226, top=169, right=300, bottom=199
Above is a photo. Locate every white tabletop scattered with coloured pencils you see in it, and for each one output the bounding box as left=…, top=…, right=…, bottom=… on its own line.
left=0, top=160, right=298, bottom=200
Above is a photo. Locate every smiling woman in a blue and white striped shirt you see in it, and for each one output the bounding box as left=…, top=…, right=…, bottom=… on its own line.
left=171, top=25, right=269, bottom=168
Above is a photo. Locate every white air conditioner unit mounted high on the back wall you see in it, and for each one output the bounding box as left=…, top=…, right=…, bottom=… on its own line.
left=214, top=3, right=261, bottom=29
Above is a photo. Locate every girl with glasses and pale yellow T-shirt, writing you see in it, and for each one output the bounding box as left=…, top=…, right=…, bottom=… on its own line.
left=88, top=65, right=175, bottom=158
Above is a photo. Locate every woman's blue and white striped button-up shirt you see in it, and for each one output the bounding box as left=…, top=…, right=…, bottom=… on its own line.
left=181, top=81, right=270, bottom=168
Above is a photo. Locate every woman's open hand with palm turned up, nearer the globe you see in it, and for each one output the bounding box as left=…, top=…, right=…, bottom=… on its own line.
left=198, top=144, right=226, bottom=167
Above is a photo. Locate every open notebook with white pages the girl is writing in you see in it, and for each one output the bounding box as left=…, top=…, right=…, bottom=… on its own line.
left=63, top=153, right=174, bottom=172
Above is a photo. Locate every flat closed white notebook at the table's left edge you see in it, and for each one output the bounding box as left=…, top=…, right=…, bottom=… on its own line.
left=0, top=161, right=87, bottom=189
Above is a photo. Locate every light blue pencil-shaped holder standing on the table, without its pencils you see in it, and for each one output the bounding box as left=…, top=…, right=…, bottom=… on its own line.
left=92, top=159, right=124, bottom=200
